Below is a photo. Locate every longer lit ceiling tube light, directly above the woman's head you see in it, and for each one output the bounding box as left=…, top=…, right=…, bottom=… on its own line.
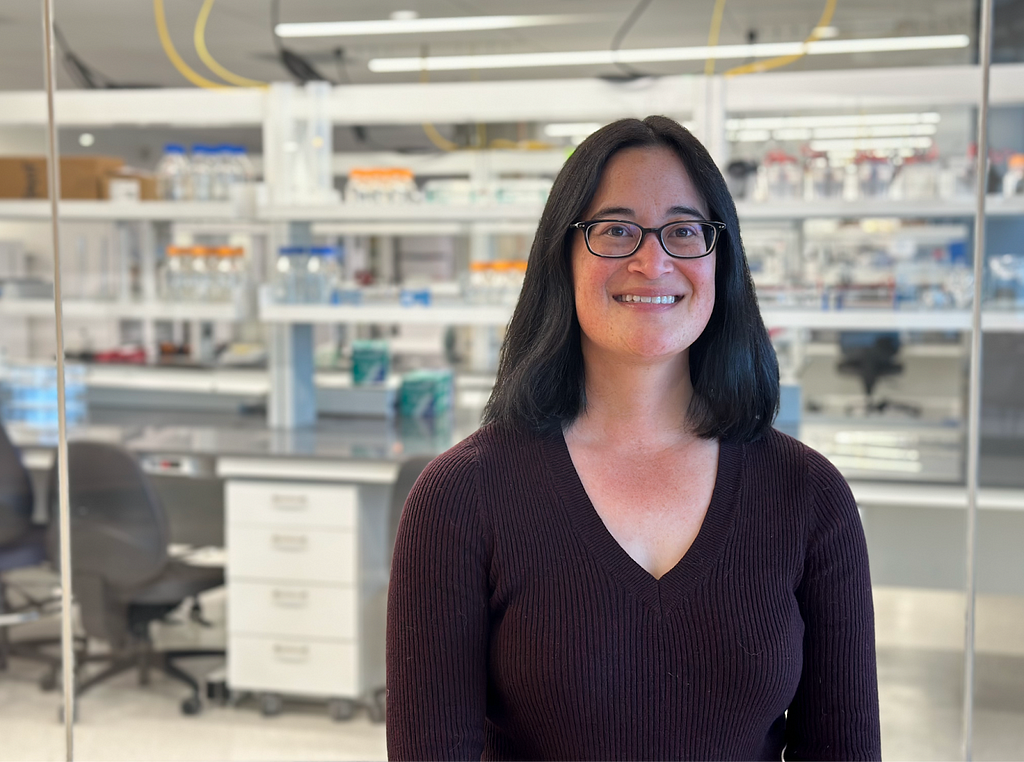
left=368, top=35, right=971, bottom=73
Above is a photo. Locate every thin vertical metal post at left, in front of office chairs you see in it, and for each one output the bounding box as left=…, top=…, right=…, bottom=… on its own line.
left=43, top=0, right=75, bottom=762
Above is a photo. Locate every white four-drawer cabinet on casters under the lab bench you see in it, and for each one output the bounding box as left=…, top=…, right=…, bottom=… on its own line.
left=225, top=478, right=389, bottom=700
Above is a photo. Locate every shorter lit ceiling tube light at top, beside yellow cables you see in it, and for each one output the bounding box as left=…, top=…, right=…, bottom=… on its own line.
left=274, top=14, right=594, bottom=37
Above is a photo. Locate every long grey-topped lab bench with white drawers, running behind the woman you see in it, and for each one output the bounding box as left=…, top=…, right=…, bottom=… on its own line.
left=14, top=408, right=1024, bottom=717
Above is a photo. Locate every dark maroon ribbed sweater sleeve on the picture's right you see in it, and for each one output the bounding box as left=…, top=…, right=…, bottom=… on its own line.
left=784, top=451, right=882, bottom=762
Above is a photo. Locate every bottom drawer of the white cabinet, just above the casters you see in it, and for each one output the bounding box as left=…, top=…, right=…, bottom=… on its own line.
left=227, top=635, right=362, bottom=696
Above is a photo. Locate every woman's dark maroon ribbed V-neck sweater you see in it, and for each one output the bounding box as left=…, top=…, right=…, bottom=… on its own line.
left=387, top=425, right=881, bottom=762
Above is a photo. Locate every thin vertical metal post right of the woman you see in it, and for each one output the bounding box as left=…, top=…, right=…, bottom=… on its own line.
left=963, top=0, right=992, bottom=762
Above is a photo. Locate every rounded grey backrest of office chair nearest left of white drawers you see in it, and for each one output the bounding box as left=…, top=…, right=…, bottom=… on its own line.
left=47, top=441, right=169, bottom=590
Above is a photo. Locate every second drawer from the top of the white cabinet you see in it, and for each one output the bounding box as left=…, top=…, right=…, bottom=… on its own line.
left=227, top=524, right=357, bottom=585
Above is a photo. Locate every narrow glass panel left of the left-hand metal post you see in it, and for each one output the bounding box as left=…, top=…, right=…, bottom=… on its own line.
left=0, top=2, right=69, bottom=761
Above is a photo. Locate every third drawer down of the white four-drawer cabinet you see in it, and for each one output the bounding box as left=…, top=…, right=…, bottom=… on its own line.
left=227, top=582, right=357, bottom=640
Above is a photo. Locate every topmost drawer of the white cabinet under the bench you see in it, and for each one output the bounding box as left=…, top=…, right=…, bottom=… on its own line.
left=225, top=481, right=358, bottom=528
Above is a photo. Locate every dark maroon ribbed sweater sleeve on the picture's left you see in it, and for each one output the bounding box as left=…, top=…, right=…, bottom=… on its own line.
left=387, top=442, right=490, bottom=762
